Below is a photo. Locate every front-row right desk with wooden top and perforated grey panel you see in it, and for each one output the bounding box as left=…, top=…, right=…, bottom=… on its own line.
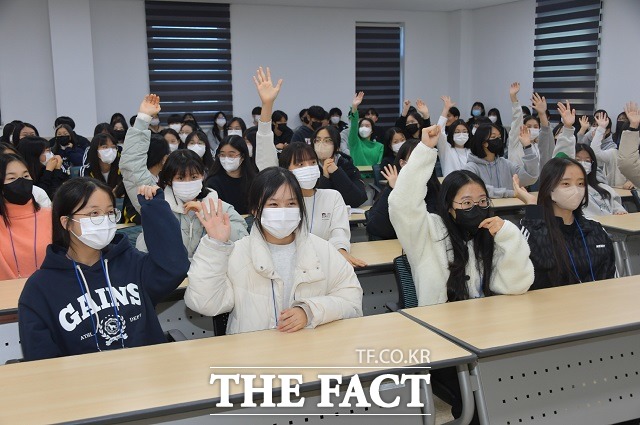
left=404, top=276, right=640, bottom=424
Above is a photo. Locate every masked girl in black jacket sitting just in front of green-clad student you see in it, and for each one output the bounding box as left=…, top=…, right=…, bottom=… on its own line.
left=311, top=125, right=367, bottom=207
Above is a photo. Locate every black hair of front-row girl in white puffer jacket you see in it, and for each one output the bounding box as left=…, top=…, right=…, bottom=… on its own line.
left=247, top=167, right=307, bottom=237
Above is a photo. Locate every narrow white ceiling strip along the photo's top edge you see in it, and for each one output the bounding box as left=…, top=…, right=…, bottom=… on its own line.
left=227, top=0, right=520, bottom=12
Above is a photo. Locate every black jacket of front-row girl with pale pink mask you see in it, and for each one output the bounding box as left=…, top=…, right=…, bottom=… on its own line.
left=520, top=205, right=616, bottom=289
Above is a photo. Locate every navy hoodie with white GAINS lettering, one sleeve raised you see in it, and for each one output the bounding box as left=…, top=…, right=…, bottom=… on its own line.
left=18, top=190, right=189, bottom=360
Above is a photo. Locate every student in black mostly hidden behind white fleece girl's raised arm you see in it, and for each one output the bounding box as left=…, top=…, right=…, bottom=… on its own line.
left=367, top=139, right=440, bottom=240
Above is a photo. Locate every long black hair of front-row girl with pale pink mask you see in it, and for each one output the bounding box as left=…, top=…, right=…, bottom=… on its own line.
left=538, top=158, right=595, bottom=282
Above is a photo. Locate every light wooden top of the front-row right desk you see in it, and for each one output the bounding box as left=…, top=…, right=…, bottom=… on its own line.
left=404, top=276, right=640, bottom=357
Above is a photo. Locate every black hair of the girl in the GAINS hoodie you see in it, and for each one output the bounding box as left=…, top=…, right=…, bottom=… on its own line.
left=51, top=177, right=116, bottom=248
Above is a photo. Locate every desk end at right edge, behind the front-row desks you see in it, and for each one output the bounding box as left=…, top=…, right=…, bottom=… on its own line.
left=592, top=213, right=640, bottom=276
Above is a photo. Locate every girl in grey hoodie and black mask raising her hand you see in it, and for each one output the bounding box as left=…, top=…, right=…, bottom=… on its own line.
left=464, top=124, right=540, bottom=198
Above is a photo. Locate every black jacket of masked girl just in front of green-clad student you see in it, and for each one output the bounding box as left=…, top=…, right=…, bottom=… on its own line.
left=317, top=153, right=367, bottom=207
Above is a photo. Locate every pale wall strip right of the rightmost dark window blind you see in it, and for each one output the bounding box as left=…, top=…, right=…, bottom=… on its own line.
left=597, top=0, right=640, bottom=116
